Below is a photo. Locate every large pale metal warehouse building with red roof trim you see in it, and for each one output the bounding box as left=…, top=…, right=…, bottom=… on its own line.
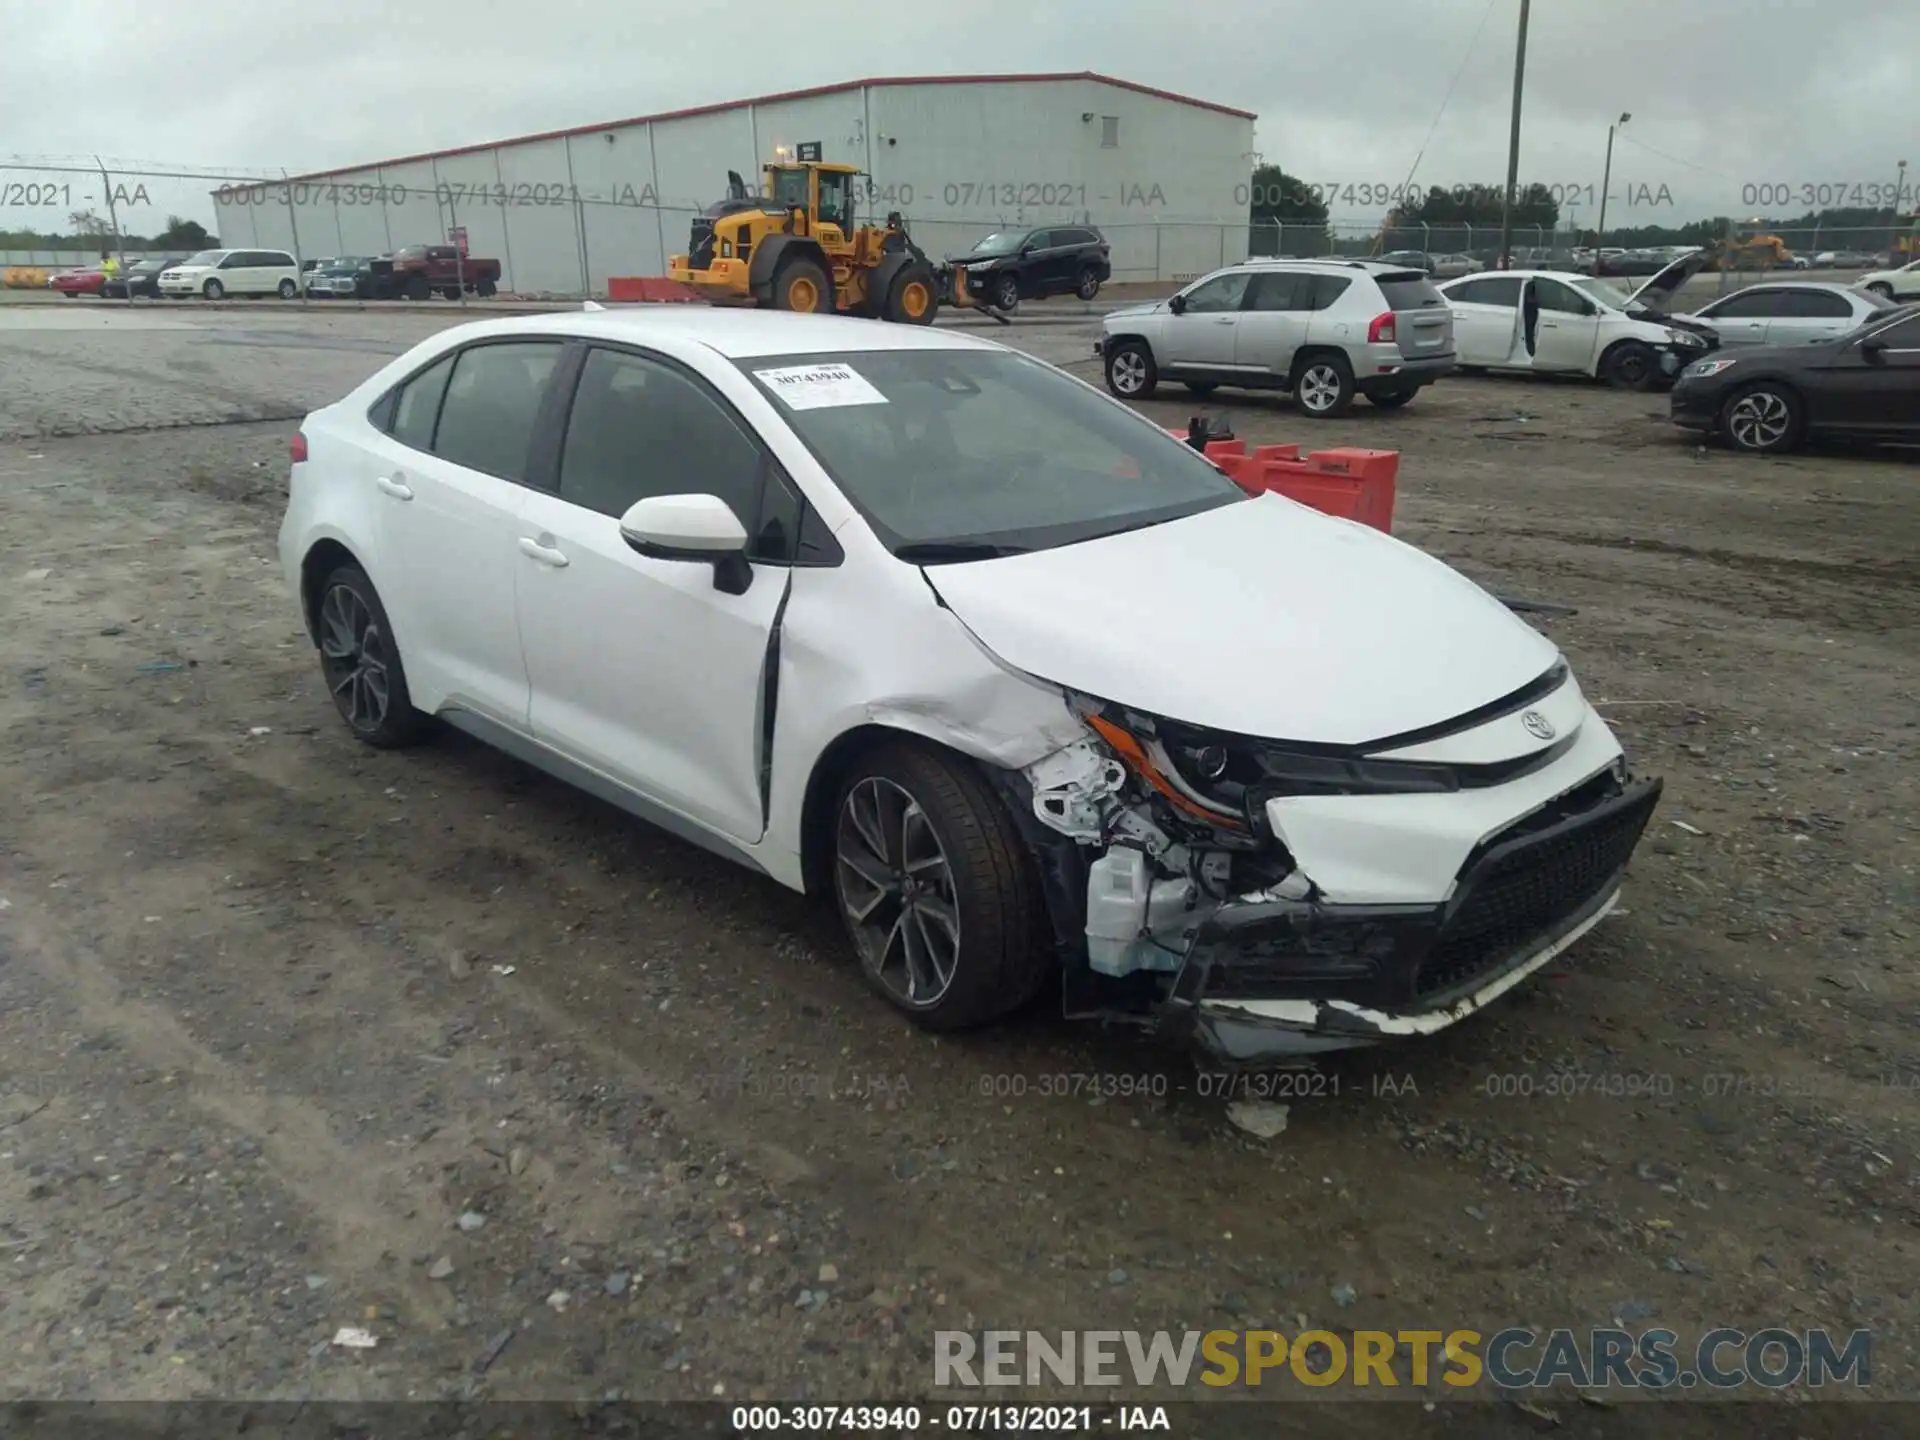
left=215, top=73, right=1256, bottom=296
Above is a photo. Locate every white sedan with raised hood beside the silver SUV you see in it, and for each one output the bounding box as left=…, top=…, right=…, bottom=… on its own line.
left=1440, top=252, right=1711, bottom=390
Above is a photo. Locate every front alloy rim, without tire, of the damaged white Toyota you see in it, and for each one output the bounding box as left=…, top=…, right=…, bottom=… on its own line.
left=833, top=776, right=960, bottom=1008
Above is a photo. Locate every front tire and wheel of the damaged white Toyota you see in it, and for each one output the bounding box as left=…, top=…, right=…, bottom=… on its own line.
left=833, top=745, right=1048, bottom=1031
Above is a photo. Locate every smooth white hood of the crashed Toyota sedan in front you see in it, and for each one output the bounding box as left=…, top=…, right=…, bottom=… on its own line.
left=925, top=495, right=1559, bottom=745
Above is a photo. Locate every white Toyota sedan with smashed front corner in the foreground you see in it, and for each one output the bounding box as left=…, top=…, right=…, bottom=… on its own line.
left=280, top=305, right=1661, bottom=1062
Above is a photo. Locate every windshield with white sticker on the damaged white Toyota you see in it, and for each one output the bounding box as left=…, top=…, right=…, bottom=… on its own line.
left=739, top=349, right=1248, bottom=556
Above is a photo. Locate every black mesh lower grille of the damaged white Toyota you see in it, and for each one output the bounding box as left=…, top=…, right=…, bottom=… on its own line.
left=1413, top=785, right=1659, bottom=998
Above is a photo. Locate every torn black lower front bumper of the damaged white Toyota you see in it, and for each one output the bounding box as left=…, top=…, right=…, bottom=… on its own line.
left=1158, top=774, right=1661, bottom=1066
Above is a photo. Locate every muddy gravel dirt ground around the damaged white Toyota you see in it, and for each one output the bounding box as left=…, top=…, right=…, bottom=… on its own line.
left=0, top=305, right=1920, bottom=1434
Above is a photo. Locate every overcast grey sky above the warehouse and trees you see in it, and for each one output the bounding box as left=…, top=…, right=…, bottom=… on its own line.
left=0, top=0, right=1920, bottom=240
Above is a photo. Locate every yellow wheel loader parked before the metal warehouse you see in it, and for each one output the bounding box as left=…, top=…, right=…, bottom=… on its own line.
left=666, top=144, right=1006, bottom=324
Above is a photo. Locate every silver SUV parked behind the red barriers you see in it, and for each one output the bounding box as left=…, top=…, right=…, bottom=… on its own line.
left=1094, top=259, right=1453, bottom=419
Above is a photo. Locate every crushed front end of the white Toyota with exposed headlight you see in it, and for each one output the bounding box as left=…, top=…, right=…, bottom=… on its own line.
left=1008, top=664, right=1661, bottom=1066
